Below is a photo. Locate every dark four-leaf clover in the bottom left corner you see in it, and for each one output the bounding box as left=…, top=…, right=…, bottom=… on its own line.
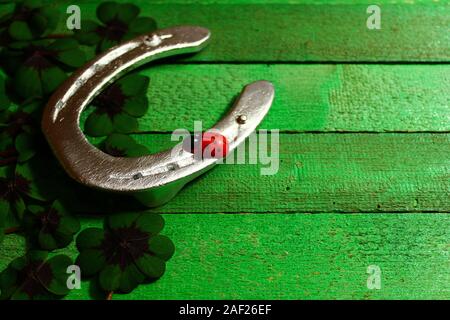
left=0, top=251, right=72, bottom=300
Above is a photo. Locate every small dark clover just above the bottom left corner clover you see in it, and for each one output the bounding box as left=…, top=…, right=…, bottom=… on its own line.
left=24, top=201, right=80, bottom=251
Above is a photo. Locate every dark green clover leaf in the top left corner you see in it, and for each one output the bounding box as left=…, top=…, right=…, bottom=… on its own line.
left=1, top=0, right=59, bottom=41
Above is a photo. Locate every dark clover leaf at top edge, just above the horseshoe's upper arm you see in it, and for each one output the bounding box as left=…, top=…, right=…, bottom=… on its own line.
left=75, top=1, right=156, bottom=52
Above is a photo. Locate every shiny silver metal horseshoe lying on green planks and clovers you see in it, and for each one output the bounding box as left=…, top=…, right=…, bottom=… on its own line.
left=42, top=26, right=274, bottom=207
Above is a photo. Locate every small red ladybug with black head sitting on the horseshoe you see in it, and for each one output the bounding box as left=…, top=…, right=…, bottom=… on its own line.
left=183, top=131, right=228, bottom=159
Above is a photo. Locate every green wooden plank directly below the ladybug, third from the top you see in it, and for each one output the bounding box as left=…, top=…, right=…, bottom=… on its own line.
left=85, top=133, right=450, bottom=213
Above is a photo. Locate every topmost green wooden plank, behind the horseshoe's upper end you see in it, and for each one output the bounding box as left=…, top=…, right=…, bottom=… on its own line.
left=72, top=0, right=450, bottom=62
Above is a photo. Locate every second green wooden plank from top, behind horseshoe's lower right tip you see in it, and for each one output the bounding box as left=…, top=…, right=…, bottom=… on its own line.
left=80, top=64, right=450, bottom=132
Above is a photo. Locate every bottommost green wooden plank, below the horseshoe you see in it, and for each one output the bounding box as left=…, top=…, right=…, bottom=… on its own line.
left=0, top=213, right=450, bottom=299
